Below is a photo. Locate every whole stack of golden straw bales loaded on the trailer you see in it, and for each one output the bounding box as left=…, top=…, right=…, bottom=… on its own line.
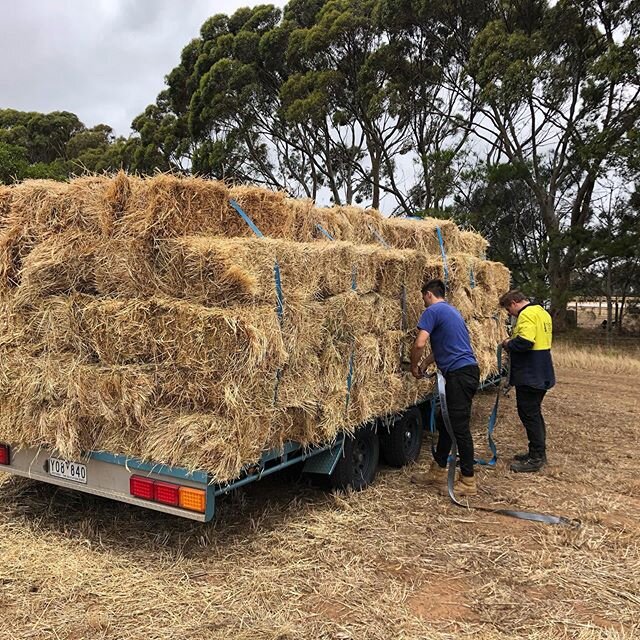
left=0, top=173, right=509, bottom=481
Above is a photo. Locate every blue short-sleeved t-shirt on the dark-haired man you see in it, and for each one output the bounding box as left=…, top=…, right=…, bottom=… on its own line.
left=418, top=302, right=478, bottom=373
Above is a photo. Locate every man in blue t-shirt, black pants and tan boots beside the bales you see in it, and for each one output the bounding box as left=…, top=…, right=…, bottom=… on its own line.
left=411, top=280, right=480, bottom=496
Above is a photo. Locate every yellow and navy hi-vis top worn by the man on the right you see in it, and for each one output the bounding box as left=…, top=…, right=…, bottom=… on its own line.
left=508, top=304, right=556, bottom=389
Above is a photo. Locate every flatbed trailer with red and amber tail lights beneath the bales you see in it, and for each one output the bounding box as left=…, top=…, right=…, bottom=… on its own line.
left=0, top=401, right=429, bottom=522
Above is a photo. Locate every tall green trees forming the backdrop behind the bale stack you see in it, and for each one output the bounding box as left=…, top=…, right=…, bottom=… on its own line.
left=0, top=0, right=640, bottom=324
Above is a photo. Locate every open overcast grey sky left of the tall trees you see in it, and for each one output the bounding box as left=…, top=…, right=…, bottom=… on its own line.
left=0, top=0, right=285, bottom=135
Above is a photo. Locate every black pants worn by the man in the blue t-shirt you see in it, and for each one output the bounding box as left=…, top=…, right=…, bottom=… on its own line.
left=435, top=365, right=480, bottom=477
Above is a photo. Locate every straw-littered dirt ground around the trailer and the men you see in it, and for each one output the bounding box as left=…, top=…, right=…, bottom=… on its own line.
left=0, top=368, right=640, bottom=640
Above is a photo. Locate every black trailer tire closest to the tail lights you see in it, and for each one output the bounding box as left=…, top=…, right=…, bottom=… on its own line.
left=329, top=426, right=380, bottom=491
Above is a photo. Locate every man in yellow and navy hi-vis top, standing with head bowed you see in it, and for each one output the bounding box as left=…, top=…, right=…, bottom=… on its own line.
left=500, top=289, right=556, bottom=473
